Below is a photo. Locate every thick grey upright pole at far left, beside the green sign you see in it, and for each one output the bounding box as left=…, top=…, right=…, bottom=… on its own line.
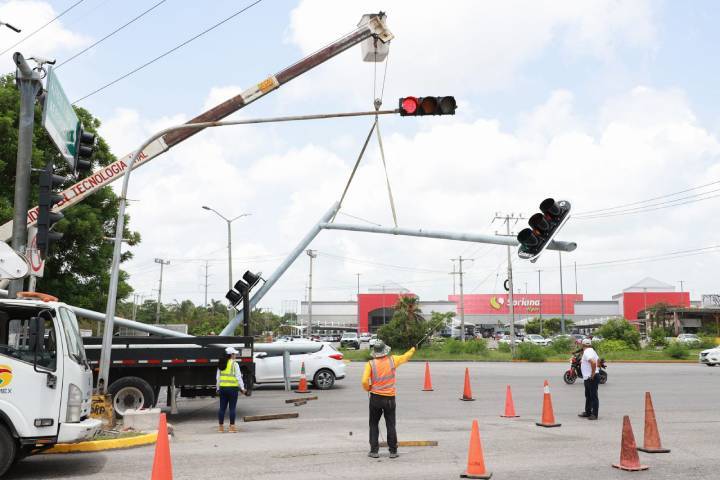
left=8, top=52, right=42, bottom=298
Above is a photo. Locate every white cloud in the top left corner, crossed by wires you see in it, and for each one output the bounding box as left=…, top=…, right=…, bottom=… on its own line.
left=0, top=0, right=90, bottom=71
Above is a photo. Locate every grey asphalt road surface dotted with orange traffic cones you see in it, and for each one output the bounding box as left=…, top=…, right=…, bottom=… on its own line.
left=7, top=363, right=720, bottom=480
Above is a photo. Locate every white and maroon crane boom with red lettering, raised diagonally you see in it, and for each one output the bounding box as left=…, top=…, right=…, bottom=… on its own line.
left=0, top=13, right=393, bottom=241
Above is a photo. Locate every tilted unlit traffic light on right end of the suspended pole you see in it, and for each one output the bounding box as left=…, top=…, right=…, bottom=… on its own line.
left=517, top=198, right=570, bottom=262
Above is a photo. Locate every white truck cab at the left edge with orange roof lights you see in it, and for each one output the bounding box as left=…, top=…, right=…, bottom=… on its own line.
left=0, top=292, right=102, bottom=476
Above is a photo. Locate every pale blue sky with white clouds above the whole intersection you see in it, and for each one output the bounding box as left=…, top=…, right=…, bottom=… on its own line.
left=0, top=0, right=720, bottom=313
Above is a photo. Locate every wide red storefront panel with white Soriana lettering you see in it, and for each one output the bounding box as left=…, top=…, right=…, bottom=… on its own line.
left=448, top=293, right=583, bottom=315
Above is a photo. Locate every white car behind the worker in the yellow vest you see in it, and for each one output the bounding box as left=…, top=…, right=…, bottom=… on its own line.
left=255, top=342, right=345, bottom=390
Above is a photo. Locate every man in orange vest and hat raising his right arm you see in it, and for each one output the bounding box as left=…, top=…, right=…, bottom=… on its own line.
left=362, top=340, right=415, bottom=458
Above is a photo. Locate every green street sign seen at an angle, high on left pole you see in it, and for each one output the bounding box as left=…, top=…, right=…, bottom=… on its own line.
left=42, top=67, right=80, bottom=167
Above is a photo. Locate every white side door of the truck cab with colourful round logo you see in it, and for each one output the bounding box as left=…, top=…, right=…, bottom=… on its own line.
left=0, top=308, right=64, bottom=437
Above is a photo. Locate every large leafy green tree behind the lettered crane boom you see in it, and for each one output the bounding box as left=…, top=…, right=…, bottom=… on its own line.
left=0, top=75, right=140, bottom=311
